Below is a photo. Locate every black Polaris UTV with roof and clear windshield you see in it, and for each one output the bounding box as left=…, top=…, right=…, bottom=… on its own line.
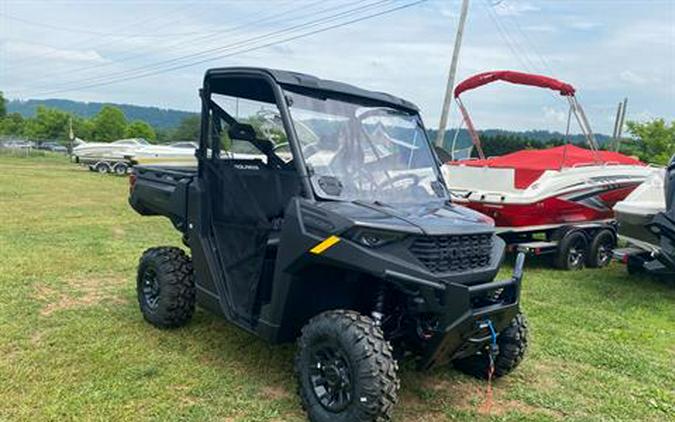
left=130, top=68, right=527, bottom=422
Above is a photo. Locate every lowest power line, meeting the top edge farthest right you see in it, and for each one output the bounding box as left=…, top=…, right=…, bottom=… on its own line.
left=26, top=0, right=428, bottom=96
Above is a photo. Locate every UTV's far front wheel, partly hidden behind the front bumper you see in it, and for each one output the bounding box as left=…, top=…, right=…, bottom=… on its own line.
left=452, top=314, right=528, bottom=379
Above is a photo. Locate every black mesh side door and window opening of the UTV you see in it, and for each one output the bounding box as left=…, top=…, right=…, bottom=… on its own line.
left=200, top=76, right=300, bottom=329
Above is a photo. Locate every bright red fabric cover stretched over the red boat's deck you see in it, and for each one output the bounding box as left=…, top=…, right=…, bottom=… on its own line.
left=450, top=145, right=645, bottom=189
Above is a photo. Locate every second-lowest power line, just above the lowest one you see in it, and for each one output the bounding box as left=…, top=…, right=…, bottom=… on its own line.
left=14, top=0, right=389, bottom=93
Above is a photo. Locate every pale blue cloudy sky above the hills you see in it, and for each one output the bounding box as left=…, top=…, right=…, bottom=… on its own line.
left=0, top=0, right=675, bottom=133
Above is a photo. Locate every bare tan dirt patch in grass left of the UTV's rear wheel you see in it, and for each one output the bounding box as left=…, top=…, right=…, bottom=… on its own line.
left=34, top=276, right=127, bottom=316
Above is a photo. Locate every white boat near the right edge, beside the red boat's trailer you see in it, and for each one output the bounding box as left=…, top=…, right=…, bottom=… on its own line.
left=614, top=169, right=666, bottom=250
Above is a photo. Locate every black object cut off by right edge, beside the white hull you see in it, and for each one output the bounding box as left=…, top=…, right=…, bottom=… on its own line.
left=647, top=155, right=675, bottom=271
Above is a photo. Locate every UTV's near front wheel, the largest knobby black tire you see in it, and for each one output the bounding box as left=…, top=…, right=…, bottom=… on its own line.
left=295, top=310, right=400, bottom=422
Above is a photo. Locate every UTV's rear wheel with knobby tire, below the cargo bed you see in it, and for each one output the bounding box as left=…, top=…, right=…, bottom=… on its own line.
left=136, top=246, right=195, bottom=328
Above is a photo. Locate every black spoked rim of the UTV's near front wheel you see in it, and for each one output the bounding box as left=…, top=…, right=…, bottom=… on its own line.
left=309, top=344, right=354, bottom=412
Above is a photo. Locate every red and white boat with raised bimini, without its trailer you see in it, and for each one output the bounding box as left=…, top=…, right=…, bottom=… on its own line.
left=443, top=71, right=653, bottom=233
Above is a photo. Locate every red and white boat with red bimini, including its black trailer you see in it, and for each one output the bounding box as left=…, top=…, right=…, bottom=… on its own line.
left=443, top=71, right=654, bottom=269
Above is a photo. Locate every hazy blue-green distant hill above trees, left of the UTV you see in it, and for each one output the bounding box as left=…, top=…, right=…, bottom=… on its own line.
left=7, top=99, right=196, bottom=129
